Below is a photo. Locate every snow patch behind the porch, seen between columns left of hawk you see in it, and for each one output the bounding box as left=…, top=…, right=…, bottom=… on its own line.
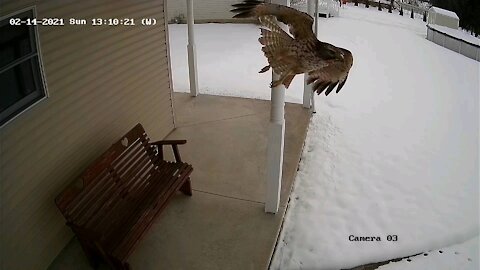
left=169, top=24, right=303, bottom=103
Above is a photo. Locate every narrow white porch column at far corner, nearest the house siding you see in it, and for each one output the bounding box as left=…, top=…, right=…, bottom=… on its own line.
left=187, top=0, right=198, bottom=97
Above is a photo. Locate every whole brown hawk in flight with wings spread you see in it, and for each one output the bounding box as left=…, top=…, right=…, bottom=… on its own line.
left=231, top=0, right=353, bottom=95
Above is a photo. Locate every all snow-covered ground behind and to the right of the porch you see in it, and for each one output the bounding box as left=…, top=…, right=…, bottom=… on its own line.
left=169, top=6, right=480, bottom=269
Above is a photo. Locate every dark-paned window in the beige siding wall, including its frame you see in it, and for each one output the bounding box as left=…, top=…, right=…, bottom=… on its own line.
left=0, top=9, right=47, bottom=127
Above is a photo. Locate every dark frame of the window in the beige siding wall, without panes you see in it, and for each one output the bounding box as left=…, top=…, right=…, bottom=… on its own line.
left=0, top=6, right=50, bottom=128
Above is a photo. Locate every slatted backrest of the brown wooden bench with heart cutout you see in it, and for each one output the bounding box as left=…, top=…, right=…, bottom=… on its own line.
left=56, top=124, right=156, bottom=219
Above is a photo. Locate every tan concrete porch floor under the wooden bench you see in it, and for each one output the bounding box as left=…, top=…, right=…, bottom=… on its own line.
left=49, top=93, right=310, bottom=270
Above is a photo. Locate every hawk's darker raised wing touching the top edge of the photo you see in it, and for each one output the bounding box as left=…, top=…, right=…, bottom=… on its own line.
left=231, top=0, right=316, bottom=39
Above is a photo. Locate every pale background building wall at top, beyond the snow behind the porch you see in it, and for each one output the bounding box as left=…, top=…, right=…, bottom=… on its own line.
left=167, top=0, right=252, bottom=23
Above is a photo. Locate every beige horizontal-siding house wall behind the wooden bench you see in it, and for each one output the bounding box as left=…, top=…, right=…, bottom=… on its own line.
left=0, top=0, right=174, bottom=269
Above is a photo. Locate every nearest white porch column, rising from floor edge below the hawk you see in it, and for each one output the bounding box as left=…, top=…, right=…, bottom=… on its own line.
left=265, top=72, right=285, bottom=214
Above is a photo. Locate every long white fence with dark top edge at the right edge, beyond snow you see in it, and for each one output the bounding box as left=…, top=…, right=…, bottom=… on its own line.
left=427, top=25, right=480, bottom=61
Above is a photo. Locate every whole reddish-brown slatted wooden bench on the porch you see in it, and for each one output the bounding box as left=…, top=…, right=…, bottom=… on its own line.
left=55, top=124, right=193, bottom=269
